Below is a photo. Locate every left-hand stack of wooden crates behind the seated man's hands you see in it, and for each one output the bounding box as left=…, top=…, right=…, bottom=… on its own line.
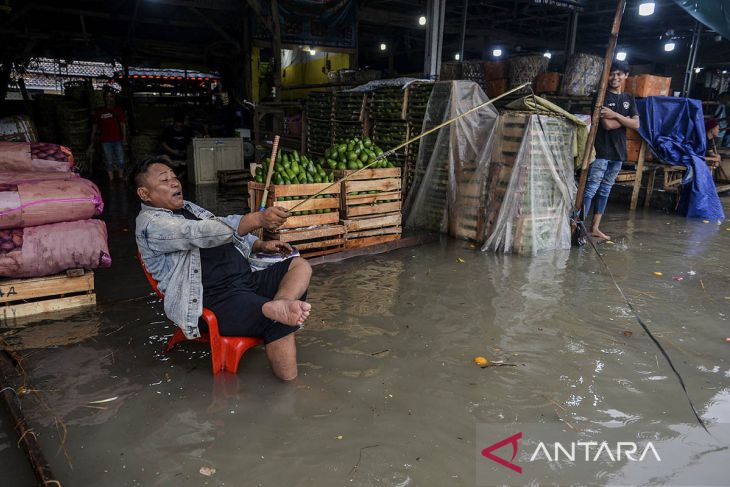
left=248, top=181, right=345, bottom=257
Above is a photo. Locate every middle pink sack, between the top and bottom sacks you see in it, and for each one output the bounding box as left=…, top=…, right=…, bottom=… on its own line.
left=0, top=176, right=104, bottom=229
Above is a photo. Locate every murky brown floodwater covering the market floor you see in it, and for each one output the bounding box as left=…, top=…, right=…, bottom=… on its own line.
left=0, top=184, right=730, bottom=487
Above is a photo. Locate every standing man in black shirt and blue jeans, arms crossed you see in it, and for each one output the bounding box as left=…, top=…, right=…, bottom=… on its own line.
left=583, top=61, right=640, bottom=240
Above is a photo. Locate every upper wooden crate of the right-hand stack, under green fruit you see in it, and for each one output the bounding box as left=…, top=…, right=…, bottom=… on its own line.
left=335, top=167, right=402, bottom=219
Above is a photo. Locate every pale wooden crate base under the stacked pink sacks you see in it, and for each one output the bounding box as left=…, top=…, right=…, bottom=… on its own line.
left=0, top=269, right=96, bottom=323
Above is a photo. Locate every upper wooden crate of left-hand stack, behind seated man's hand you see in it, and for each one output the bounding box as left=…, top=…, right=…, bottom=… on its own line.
left=248, top=181, right=340, bottom=228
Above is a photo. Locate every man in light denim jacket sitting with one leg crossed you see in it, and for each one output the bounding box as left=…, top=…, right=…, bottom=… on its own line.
left=134, top=159, right=312, bottom=380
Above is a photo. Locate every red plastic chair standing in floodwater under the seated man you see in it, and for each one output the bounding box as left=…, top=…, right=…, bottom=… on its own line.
left=137, top=252, right=263, bottom=375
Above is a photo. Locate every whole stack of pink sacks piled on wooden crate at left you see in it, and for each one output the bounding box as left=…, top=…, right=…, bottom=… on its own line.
left=0, top=142, right=111, bottom=277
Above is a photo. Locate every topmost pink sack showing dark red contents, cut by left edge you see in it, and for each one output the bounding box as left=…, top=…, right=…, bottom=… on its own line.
left=0, top=142, right=74, bottom=172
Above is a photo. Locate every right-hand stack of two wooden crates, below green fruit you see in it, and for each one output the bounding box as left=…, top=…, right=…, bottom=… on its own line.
left=335, top=167, right=402, bottom=249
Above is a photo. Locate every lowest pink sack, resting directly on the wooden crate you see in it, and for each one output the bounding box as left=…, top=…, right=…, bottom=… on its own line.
left=0, top=220, right=112, bottom=277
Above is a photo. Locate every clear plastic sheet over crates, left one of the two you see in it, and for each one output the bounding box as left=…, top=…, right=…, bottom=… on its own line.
left=404, top=81, right=498, bottom=241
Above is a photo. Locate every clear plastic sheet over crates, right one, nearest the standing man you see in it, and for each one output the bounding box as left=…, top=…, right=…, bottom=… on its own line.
left=482, top=112, right=577, bottom=255
